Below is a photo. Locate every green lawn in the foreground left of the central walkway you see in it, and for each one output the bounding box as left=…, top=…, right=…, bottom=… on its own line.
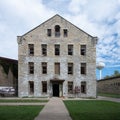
left=0, top=106, right=43, bottom=120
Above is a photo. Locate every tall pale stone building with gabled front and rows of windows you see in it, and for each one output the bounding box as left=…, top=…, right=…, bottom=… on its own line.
left=17, top=15, right=97, bottom=97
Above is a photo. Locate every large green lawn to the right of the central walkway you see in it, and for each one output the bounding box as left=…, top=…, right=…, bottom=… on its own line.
left=64, top=100, right=120, bottom=120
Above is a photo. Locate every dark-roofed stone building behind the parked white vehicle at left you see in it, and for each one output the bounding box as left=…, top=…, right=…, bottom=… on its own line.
left=0, top=57, right=18, bottom=95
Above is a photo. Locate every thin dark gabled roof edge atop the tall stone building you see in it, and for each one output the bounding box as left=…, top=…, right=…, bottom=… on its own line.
left=22, top=14, right=93, bottom=37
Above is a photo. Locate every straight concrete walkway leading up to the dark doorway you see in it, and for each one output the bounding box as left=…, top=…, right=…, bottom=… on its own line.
left=35, top=97, right=72, bottom=120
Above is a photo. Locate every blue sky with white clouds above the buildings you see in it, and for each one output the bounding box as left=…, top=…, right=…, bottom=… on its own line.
left=0, top=0, right=120, bottom=78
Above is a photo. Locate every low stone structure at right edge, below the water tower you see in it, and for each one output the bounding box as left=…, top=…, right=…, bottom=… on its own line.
left=97, top=76, right=120, bottom=94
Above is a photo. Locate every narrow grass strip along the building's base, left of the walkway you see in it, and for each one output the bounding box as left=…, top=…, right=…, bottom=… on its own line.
left=0, top=99, right=48, bottom=103
